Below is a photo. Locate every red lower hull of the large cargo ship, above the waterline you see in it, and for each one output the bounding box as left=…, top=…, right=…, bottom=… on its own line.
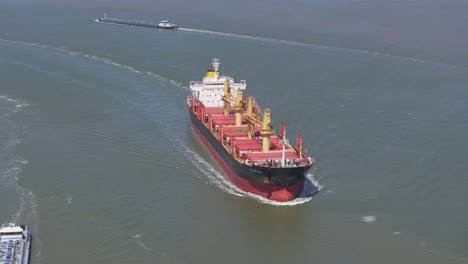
left=192, top=124, right=305, bottom=202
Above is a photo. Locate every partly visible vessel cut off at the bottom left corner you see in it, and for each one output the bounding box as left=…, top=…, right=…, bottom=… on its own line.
left=0, top=224, right=31, bottom=264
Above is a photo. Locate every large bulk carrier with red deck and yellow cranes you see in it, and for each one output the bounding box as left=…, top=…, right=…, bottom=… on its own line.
left=187, top=58, right=314, bottom=202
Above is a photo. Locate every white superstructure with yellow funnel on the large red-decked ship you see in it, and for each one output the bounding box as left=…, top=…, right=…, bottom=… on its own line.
left=190, top=58, right=247, bottom=107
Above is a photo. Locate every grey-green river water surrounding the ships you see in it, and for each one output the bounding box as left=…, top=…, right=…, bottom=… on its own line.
left=0, top=0, right=468, bottom=264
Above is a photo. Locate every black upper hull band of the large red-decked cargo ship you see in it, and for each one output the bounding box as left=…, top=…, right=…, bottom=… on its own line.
left=188, top=109, right=312, bottom=187
